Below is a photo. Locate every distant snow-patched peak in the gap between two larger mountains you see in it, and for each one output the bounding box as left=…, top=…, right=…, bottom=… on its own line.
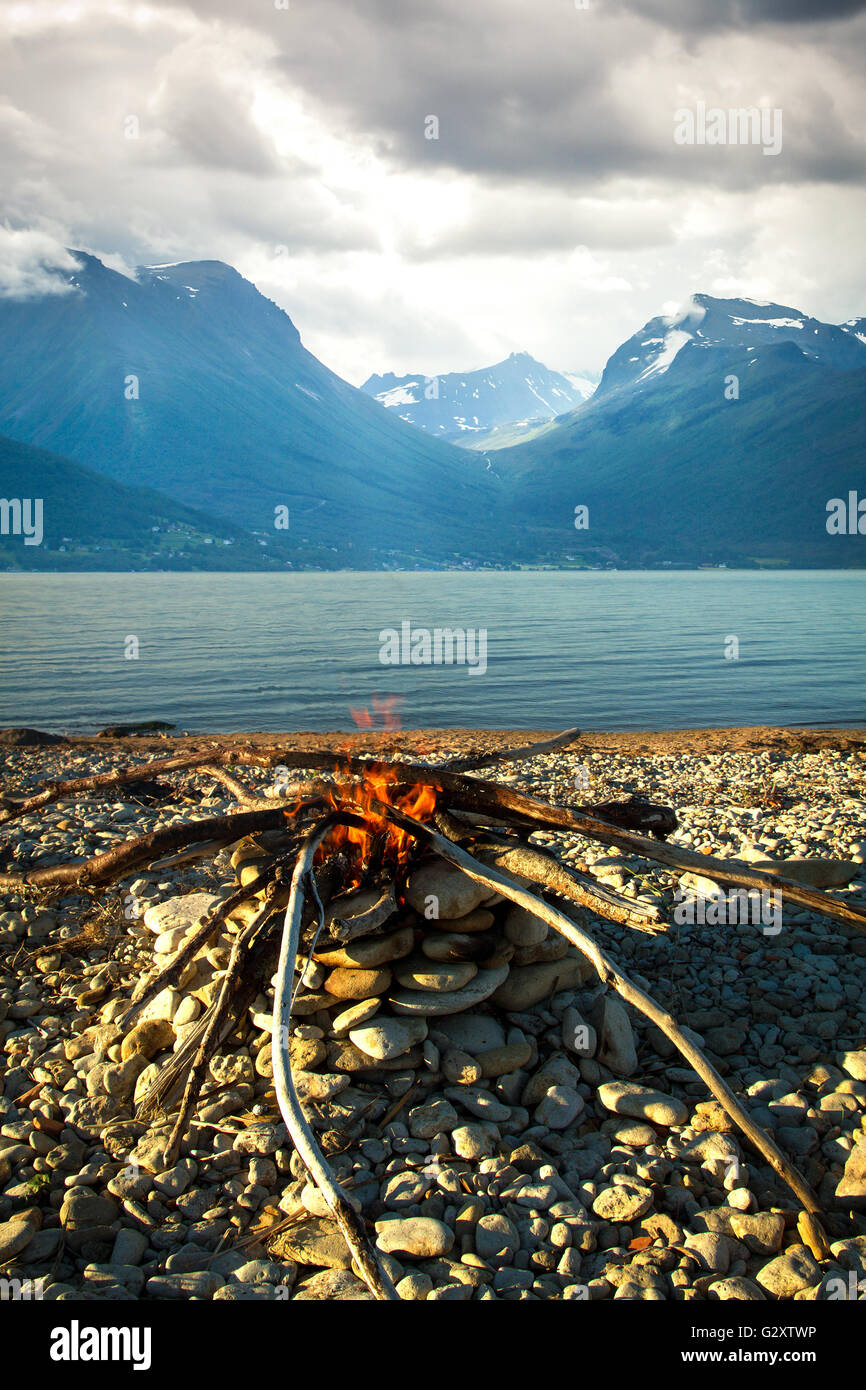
left=361, top=352, right=596, bottom=446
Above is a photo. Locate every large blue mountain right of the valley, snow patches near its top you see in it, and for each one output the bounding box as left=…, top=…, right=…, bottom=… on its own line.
left=500, top=287, right=866, bottom=567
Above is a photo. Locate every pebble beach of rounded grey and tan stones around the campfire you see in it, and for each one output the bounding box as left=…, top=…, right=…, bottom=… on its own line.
left=0, top=731, right=866, bottom=1301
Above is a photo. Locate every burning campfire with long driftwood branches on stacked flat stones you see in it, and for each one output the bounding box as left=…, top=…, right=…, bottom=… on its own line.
left=0, top=730, right=866, bottom=1298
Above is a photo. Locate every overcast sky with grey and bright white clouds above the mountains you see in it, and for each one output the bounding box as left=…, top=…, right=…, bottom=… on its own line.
left=0, top=0, right=866, bottom=384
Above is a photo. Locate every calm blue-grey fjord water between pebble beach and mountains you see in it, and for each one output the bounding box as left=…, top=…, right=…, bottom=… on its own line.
left=0, top=570, right=866, bottom=733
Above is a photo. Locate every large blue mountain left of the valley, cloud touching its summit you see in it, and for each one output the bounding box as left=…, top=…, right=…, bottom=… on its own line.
left=0, top=252, right=495, bottom=559
